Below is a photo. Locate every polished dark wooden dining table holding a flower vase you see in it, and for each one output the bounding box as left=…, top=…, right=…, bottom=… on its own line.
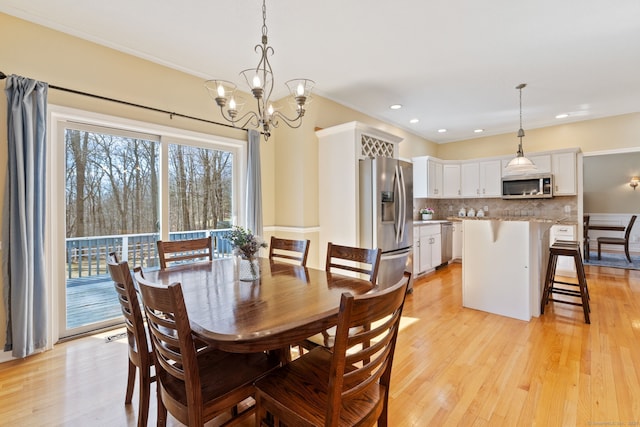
left=144, top=258, right=372, bottom=353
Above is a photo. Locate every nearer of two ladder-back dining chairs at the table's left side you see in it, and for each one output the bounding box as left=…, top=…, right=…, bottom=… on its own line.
left=134, top=267, right=279, bottom=427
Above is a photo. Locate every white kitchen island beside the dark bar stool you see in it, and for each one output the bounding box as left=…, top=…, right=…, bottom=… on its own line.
left=462, top=218, right=572, bottom=321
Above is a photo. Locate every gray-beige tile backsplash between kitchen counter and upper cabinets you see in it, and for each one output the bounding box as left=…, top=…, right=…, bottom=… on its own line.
left=413, top=196, right=578, bottom=220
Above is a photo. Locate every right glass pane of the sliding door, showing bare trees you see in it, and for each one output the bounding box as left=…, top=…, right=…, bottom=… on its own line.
left=169, top=144, right=233, bottom=232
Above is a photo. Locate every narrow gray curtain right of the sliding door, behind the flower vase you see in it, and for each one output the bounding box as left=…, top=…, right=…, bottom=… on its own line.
left=246, top=129, right=264, bottom=236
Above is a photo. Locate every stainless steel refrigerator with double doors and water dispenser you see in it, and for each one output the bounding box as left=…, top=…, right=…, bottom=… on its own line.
left=359, top=157, right=413, bottom=289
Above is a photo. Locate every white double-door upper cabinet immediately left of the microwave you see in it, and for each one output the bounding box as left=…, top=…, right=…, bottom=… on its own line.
left=461, top=160, right=502, bottom=197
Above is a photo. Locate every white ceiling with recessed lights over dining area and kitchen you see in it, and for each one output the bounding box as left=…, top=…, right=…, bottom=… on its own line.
left=0, top=0, right=640, bottom=143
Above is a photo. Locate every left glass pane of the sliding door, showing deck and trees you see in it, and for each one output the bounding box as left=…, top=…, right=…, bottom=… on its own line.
left=64, top=128, right=159, bottom=330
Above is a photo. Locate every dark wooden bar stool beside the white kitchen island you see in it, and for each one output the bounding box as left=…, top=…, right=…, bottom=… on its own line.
left=540, top=240, right=591, bottom=324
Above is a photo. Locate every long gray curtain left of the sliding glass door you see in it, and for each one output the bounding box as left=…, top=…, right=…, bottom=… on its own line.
left=2, top=75, right=48, bottom=357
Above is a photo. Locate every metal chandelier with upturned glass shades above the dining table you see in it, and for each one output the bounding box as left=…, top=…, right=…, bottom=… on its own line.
left=204, top=0, right=315, bottom=141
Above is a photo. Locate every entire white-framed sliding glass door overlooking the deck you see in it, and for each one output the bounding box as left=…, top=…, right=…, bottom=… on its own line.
left=58, top=113, right=240, bottom=337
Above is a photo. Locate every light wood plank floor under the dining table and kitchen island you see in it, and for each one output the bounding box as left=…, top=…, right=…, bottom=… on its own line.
left=0, top=264, right=640, bottom=426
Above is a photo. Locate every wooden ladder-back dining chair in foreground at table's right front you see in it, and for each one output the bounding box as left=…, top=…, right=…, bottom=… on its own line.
left=256, top=272, right=411, bottom=426
